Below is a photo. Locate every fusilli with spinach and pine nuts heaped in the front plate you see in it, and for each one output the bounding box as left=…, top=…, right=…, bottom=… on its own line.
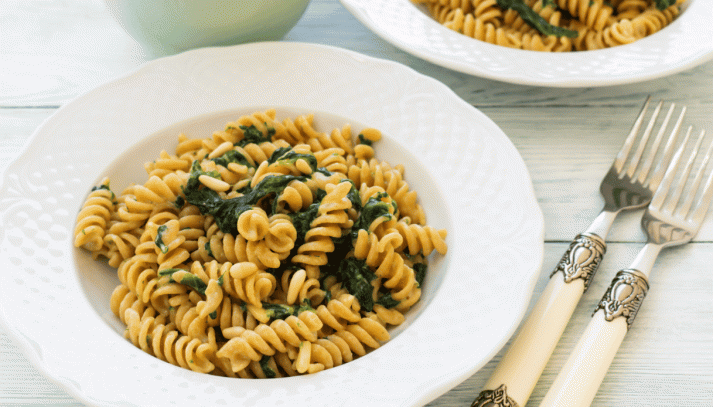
left=74, top=109, right=444, bottom=378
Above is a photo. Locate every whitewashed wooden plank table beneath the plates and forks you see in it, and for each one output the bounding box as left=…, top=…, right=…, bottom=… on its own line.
left=0, top=0, right=713, bottom=407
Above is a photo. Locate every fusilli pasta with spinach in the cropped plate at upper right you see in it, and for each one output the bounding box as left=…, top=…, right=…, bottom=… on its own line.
left=411, top=0, right=686, bottom=52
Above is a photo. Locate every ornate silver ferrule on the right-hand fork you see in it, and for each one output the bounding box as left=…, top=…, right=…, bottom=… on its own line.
left=594, top=269, right=649, bottom=329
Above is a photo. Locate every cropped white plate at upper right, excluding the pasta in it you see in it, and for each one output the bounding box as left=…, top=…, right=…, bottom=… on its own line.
left=340, top=0, right=713, bottom=87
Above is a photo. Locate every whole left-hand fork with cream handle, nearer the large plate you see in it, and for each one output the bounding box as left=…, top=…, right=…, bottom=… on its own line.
left=471, top=97, right=686, bottom=407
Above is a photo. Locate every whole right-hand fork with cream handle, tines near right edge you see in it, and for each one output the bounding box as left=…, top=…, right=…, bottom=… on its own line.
left=540, top=128, right=713, bottom=407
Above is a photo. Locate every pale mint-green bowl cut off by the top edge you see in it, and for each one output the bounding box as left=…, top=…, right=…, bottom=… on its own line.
left=105, top=0, right=309, bottom=55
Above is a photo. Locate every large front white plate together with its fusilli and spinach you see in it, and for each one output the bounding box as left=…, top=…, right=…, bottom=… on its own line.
left=0, top=42, right=544, bottom=407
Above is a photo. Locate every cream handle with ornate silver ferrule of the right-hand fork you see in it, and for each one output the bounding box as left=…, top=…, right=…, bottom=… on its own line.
left=540, top=269, right=649, bottom=407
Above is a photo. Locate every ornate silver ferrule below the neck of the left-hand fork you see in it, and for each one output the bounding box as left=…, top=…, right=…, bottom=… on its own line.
left=550, top=233, right=607, bottom=291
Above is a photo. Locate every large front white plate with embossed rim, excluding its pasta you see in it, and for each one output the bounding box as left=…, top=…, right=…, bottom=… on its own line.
left=0, top=43, right=543, bottom=406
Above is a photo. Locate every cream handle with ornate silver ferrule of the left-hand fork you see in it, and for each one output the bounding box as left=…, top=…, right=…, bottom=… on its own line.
left=471, top=233, right=606, bottom=407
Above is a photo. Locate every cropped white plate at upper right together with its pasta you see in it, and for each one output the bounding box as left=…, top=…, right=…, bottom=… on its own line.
left=341, top=0, right=713, bottom=87
